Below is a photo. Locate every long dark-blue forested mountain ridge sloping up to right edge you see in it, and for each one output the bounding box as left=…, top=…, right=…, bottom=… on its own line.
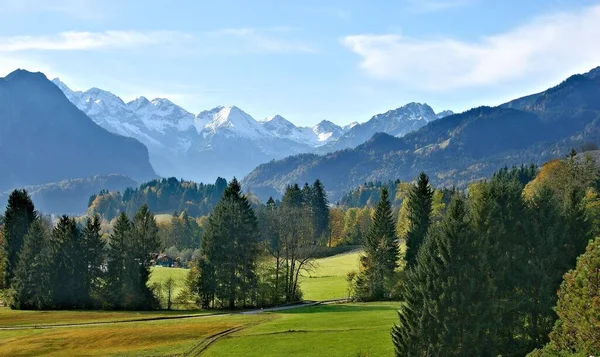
left=243, top=68, right=600, bottom=201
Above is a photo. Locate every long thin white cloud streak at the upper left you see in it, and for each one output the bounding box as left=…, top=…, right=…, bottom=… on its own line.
left=0, top=31, right=190, bottom=52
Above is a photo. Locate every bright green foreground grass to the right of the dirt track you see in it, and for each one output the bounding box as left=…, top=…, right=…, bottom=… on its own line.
left=203, top=302, right=398, bottom=357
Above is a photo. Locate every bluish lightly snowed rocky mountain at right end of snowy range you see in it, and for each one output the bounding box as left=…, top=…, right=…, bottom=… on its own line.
left=316, top=103, right=453, bottom=154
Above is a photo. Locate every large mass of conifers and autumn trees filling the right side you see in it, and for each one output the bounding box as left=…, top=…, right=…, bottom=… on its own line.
left=342, top=153, right=600, bottom=357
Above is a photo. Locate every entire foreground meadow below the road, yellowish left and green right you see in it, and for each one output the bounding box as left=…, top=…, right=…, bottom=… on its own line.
left=0, top=303, right=398, bottom=357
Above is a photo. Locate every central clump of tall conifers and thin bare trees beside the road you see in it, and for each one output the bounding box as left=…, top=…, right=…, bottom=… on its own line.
left=187, top=179, right=329, bottom=308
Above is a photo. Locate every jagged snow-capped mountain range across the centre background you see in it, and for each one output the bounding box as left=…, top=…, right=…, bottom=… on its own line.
left=53, top=78, right=449, bottom=182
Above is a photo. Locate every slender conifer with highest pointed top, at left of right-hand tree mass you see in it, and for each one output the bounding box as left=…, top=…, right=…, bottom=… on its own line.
left=404, top=173, right=433, bottom=268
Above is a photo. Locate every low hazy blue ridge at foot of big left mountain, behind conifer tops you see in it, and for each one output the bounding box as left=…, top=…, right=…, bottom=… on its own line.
left=0, top=175, right=138, bottom=215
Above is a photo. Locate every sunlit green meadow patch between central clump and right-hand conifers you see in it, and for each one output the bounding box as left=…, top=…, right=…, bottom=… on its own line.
left=300, top=251, right=362, bottom=300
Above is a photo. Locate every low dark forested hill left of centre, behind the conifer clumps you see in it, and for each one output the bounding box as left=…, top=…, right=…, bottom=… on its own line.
left=88, top=177, right=227, bottom=220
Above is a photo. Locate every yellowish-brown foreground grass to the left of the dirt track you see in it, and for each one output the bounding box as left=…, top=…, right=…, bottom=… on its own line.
left=0, top=315, right=268, bottom=356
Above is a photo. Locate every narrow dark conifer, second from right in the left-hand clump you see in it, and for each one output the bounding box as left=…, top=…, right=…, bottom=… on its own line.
left=104, top=213, right=131, bottom=309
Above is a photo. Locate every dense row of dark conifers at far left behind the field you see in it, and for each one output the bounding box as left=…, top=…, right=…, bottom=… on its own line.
left=2, top=190, right=159, bottom=310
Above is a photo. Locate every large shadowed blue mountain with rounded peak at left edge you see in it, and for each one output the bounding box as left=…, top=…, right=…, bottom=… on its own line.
left=0, top=70, right=155, bottom=191
